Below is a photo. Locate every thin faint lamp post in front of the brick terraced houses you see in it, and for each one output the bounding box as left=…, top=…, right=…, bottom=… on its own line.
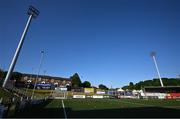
left=31, top=51, right=44, bottom=99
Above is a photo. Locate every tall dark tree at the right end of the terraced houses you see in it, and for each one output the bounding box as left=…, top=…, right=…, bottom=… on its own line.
left=70, top=73, right=81, bottom=88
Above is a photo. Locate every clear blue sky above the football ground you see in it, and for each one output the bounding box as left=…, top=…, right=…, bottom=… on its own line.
left=0, top=0, right=180, bottom=87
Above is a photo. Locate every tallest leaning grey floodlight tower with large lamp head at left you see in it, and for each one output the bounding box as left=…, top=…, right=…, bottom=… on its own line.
left=2, top=6, right=39, bottom=87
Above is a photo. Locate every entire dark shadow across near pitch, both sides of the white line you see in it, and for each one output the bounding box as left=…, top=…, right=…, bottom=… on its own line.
left=15, top=100, right=180, bottom=118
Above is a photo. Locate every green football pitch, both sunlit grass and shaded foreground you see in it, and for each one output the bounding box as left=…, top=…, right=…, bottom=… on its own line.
left=17, top=99, right=180, bottom=118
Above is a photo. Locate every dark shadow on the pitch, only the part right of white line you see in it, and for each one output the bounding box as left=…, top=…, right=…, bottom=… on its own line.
left=66, top=107, right=180, bottom=118
